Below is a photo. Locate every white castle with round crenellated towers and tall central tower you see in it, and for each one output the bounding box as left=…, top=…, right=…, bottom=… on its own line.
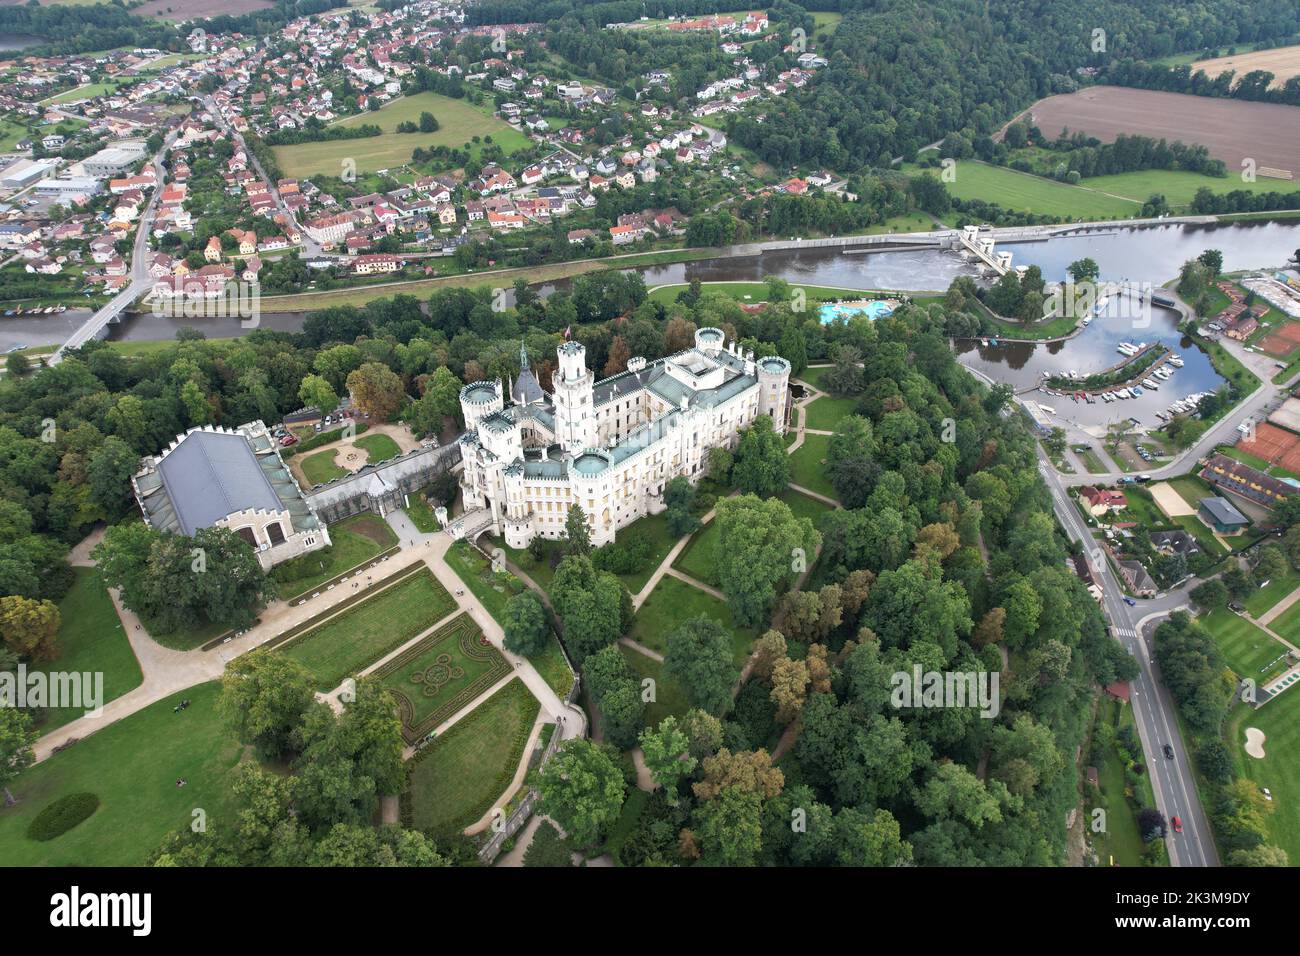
left=460, top=328, right=790, bottom=548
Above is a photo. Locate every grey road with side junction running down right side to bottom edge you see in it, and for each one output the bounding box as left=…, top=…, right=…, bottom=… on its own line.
left=1039, top=449, right=1219, bottom=866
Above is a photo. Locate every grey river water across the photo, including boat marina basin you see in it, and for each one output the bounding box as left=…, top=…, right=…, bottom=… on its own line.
left=10, top=220, right=1300, bottom=403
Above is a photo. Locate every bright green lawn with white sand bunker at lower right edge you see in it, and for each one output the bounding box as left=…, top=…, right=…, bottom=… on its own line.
left=1227, top=687, right=1300, bottom=866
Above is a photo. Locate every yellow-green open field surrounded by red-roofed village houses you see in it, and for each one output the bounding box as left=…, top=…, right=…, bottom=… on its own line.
left=274, top=92, right=528, bottom=178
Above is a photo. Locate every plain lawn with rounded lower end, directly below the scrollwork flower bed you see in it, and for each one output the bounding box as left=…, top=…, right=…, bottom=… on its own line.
left=403, top=680, right=540, bottom=836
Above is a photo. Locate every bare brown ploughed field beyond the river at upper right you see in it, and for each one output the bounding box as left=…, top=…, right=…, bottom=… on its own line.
left=1013, top=86, right=1300, bottom=183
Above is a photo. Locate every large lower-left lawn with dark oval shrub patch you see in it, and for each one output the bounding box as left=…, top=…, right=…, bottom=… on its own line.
left=0, top=682, right=243, bottom=866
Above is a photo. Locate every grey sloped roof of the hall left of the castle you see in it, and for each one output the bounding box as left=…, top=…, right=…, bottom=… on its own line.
left=157, top=432, right=283, bottom=535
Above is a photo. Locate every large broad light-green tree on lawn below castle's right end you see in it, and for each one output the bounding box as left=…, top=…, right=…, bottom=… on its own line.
left=714, top=494, right=822, bottom=627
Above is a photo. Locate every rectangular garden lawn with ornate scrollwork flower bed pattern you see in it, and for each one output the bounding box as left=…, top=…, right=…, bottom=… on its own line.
left=374, top=614, right=511, bottom=744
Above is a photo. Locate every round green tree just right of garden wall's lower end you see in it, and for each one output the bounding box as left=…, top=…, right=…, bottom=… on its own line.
left=536, top=737, right=627, bottom=848
